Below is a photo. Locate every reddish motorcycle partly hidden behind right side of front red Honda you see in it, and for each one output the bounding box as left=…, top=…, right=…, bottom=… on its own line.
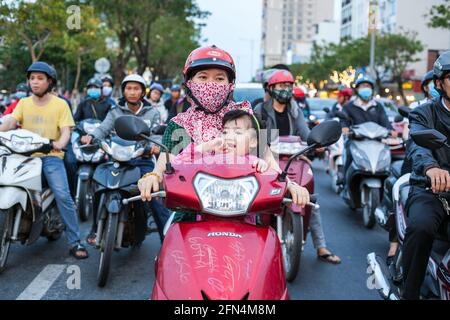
left=270, top=136, right=319, bottom=282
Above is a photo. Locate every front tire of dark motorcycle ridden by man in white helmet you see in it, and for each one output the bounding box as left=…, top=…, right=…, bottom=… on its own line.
left=97, top=213, right=119, bottom=287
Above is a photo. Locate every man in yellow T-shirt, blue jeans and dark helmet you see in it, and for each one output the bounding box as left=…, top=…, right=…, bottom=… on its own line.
left=0, top=61, right=88, bottom=259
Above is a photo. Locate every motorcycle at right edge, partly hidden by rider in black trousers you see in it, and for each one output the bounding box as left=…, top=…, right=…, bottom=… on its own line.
left=367, top=130, right=450, bottom=300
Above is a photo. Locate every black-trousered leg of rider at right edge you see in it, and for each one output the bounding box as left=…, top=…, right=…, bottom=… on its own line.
left=403, top=187, right=446, bottom=299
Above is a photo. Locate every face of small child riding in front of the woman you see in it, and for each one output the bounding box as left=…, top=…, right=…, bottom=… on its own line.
left=222, top=117, right=258, bottom=156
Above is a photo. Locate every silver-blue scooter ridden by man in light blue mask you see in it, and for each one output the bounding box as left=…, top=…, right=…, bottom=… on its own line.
left=341, top=116, right=391, bottom=228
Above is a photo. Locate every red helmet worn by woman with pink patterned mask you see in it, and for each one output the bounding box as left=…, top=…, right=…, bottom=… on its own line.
left=183, top=46, right=236, bottom=82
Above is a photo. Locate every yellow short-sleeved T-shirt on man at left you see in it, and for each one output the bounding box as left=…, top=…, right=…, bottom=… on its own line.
left=12, top=95, right=75, bottom=158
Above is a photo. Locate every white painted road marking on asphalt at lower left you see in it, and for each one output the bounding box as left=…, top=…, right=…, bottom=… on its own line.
left=16, top=264, right=67, bottom=300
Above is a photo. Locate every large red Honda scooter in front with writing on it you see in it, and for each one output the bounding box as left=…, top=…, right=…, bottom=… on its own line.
left=116, top=117, right=341, bottom=300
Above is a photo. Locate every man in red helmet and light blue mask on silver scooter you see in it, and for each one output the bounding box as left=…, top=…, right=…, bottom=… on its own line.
left=336, top=77, right=398, bottom=185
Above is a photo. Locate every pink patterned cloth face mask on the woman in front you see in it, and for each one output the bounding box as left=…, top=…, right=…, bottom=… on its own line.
left=186, top=80, right=234, bottom=113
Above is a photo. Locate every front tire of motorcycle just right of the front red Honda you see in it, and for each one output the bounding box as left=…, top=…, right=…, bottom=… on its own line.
left=281, top=209, right=303, bottom=282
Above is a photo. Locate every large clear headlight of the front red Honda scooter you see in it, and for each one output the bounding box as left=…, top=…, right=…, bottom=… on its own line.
left=194, top=173, right=259, bottom=217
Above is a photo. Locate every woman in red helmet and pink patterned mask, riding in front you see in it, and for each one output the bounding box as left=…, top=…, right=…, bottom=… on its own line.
left=138, top=46, right=309, bottom=205
